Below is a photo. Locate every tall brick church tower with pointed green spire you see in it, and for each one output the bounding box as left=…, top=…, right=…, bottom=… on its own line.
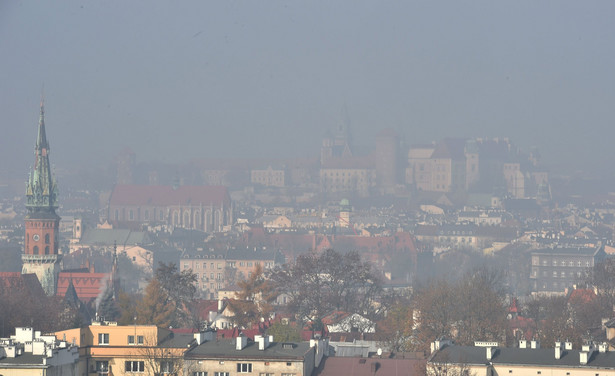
left=21, top=101, right=62, bottom=295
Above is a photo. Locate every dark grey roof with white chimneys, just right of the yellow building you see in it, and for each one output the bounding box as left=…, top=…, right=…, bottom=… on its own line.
left=186, top=338, right=311, bottom=360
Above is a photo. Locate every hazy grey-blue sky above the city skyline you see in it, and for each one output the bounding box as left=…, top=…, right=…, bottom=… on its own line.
left=0, top=0, right=615, bottom=179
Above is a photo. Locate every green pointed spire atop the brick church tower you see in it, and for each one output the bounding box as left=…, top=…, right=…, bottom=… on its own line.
left=26, top=100, right=58, bottom=213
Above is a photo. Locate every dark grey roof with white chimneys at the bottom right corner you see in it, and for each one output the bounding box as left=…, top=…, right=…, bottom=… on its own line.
left=431, top=345, right=615, bottom=368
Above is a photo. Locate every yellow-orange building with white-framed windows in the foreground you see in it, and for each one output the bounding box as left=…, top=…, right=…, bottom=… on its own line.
left=55, top=322, right=208, bottom=376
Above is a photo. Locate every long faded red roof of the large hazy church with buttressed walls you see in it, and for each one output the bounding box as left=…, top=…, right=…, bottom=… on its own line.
left=110, top=185, right=230, bottom=206
